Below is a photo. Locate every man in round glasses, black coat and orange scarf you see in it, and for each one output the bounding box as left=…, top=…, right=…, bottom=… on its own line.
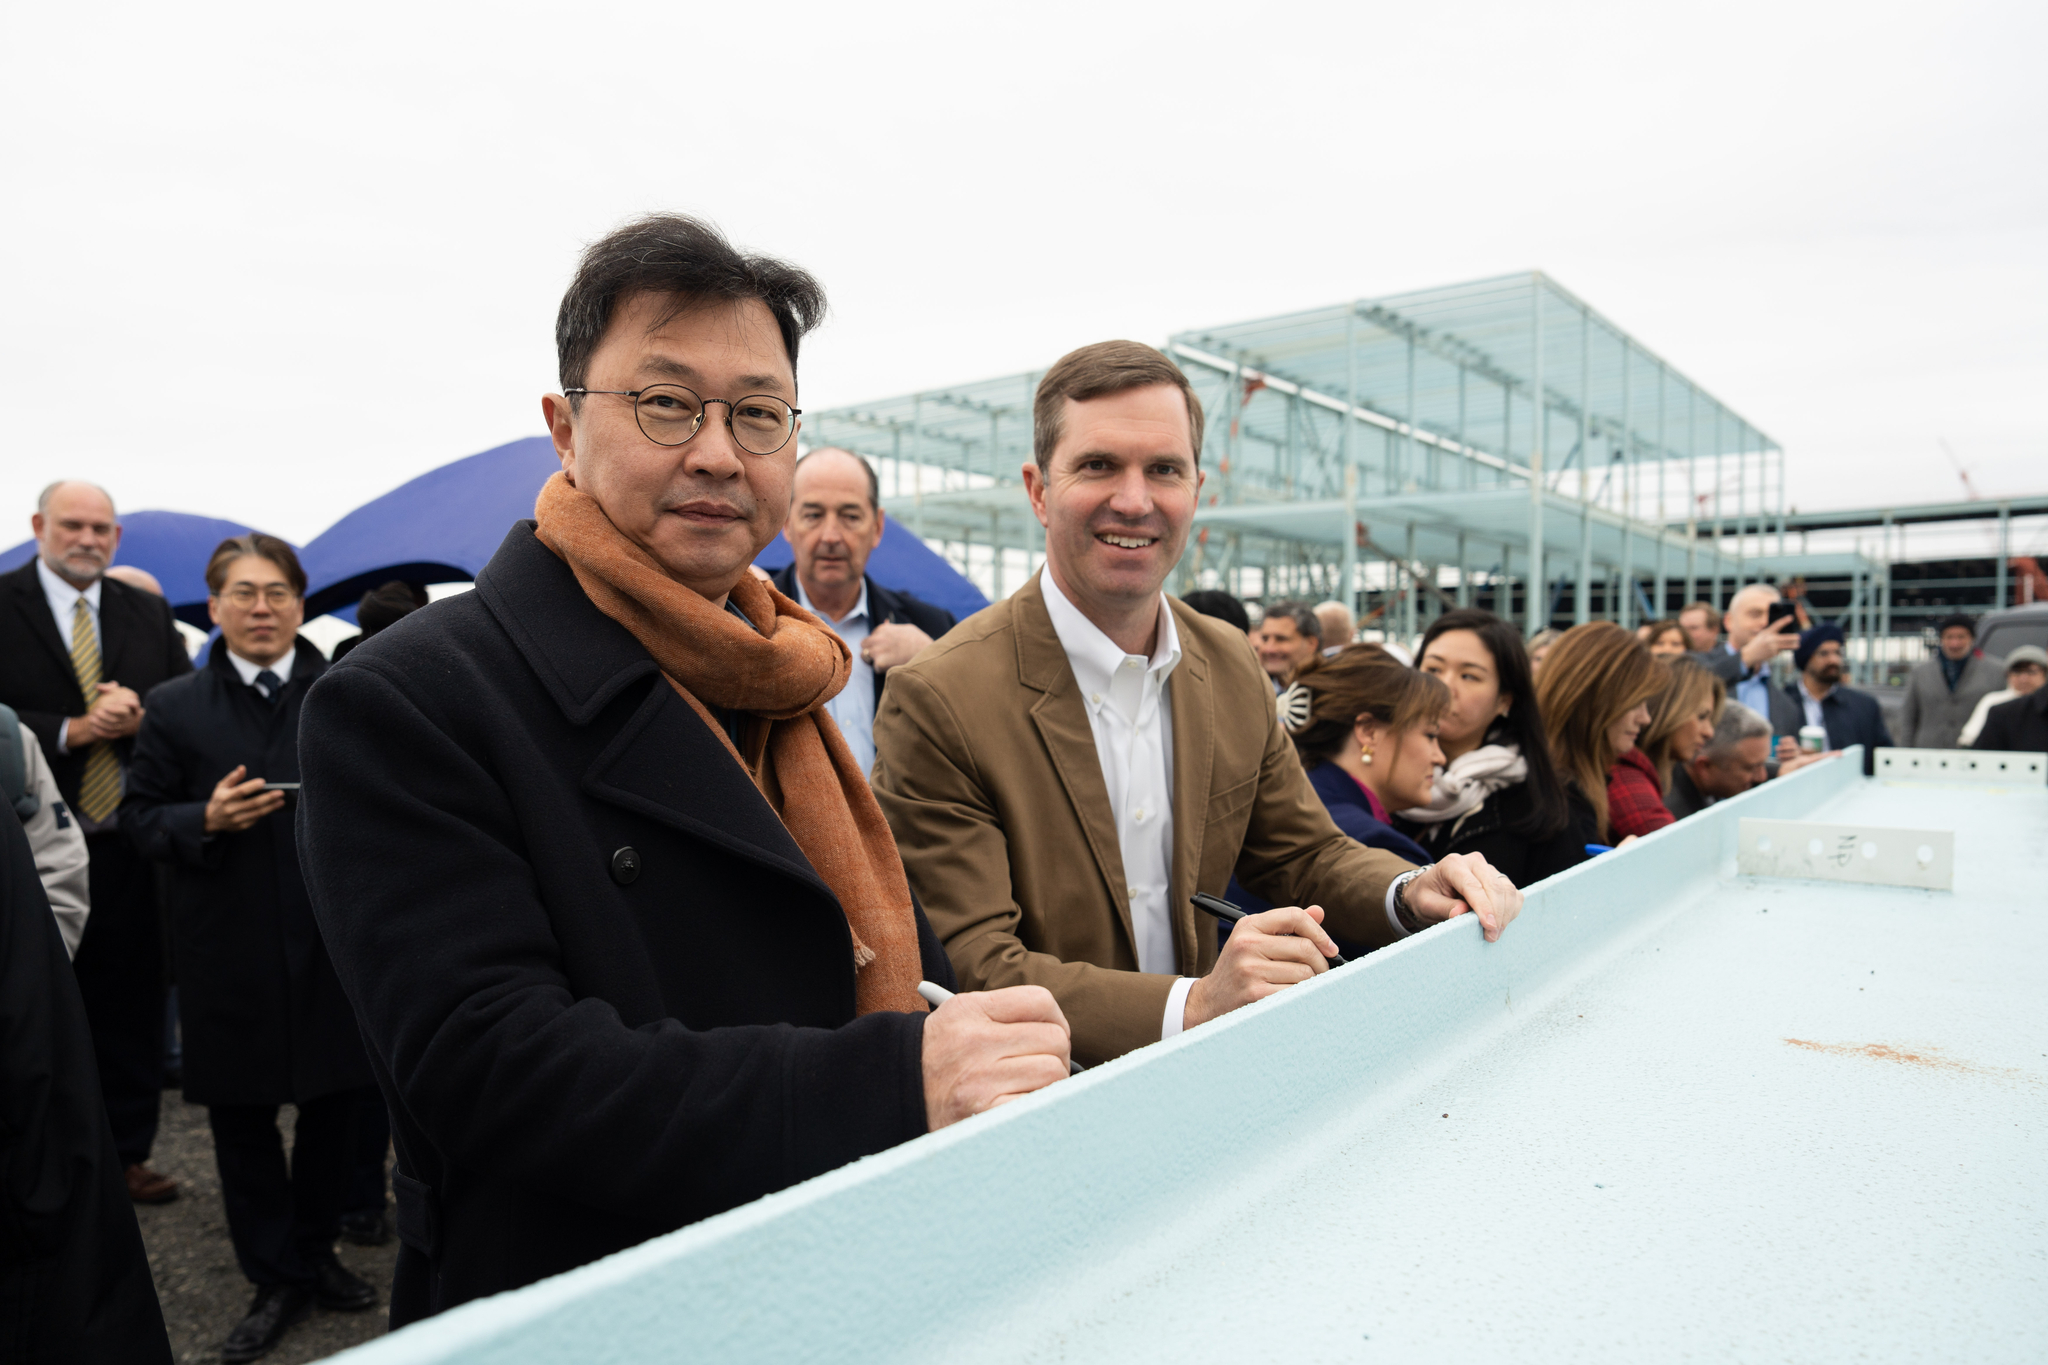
left=299, top=217, right=1069, bottom=1326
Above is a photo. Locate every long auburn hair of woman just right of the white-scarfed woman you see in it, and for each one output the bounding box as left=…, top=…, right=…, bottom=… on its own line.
left=1536, top=620, right=1669, bottom=837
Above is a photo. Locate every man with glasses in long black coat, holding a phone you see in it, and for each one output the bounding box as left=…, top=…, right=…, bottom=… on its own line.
left=121, top=532, right=383, bottom=1365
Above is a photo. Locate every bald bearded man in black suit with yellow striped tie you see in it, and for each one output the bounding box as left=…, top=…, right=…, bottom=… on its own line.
left=0, top=483, right=193, bottom=1203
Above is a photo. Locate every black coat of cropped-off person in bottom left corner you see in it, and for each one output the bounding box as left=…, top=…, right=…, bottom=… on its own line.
left=0, top=810, right=170, bottom=1365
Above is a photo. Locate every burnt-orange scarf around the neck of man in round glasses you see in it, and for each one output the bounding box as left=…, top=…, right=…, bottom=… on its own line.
left=535, top=473, right=926, bottom=1015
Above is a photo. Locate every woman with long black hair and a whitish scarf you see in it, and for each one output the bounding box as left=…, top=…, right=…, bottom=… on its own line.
left=1395, top=608, right=1585, bottom=886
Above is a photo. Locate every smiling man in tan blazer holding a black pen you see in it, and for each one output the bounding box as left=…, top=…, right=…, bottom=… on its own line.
left=874, top=342, right=1522, bottom=1062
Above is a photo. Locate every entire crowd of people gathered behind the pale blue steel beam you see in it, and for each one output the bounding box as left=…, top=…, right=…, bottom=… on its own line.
left=0, top=217, right=2048, bottom=1361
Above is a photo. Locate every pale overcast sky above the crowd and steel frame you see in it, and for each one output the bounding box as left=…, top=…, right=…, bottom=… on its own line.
left=0, top=0, right=2048, bottom=544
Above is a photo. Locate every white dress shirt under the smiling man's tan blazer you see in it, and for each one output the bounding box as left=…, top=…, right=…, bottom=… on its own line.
left=1038, top=571, right=1194, bottom=1038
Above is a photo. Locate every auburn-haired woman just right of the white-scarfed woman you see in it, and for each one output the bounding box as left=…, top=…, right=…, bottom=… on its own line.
left=1536, top=620, right=1673, bottom=843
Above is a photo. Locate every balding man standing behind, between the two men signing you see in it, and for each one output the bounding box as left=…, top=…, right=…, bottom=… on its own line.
left=770, top=446, right=952, bottom=772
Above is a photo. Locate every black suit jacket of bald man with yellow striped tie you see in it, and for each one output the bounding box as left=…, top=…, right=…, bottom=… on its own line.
left=0, top=559, right=193, bottom=808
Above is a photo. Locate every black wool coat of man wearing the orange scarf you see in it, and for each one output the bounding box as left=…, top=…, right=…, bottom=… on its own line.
left=299, top=522, right=952, bottom=1326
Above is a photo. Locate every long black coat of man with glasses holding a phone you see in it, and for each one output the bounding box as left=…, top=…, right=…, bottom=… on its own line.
left=121, top=639, right=371, bottom=1105
